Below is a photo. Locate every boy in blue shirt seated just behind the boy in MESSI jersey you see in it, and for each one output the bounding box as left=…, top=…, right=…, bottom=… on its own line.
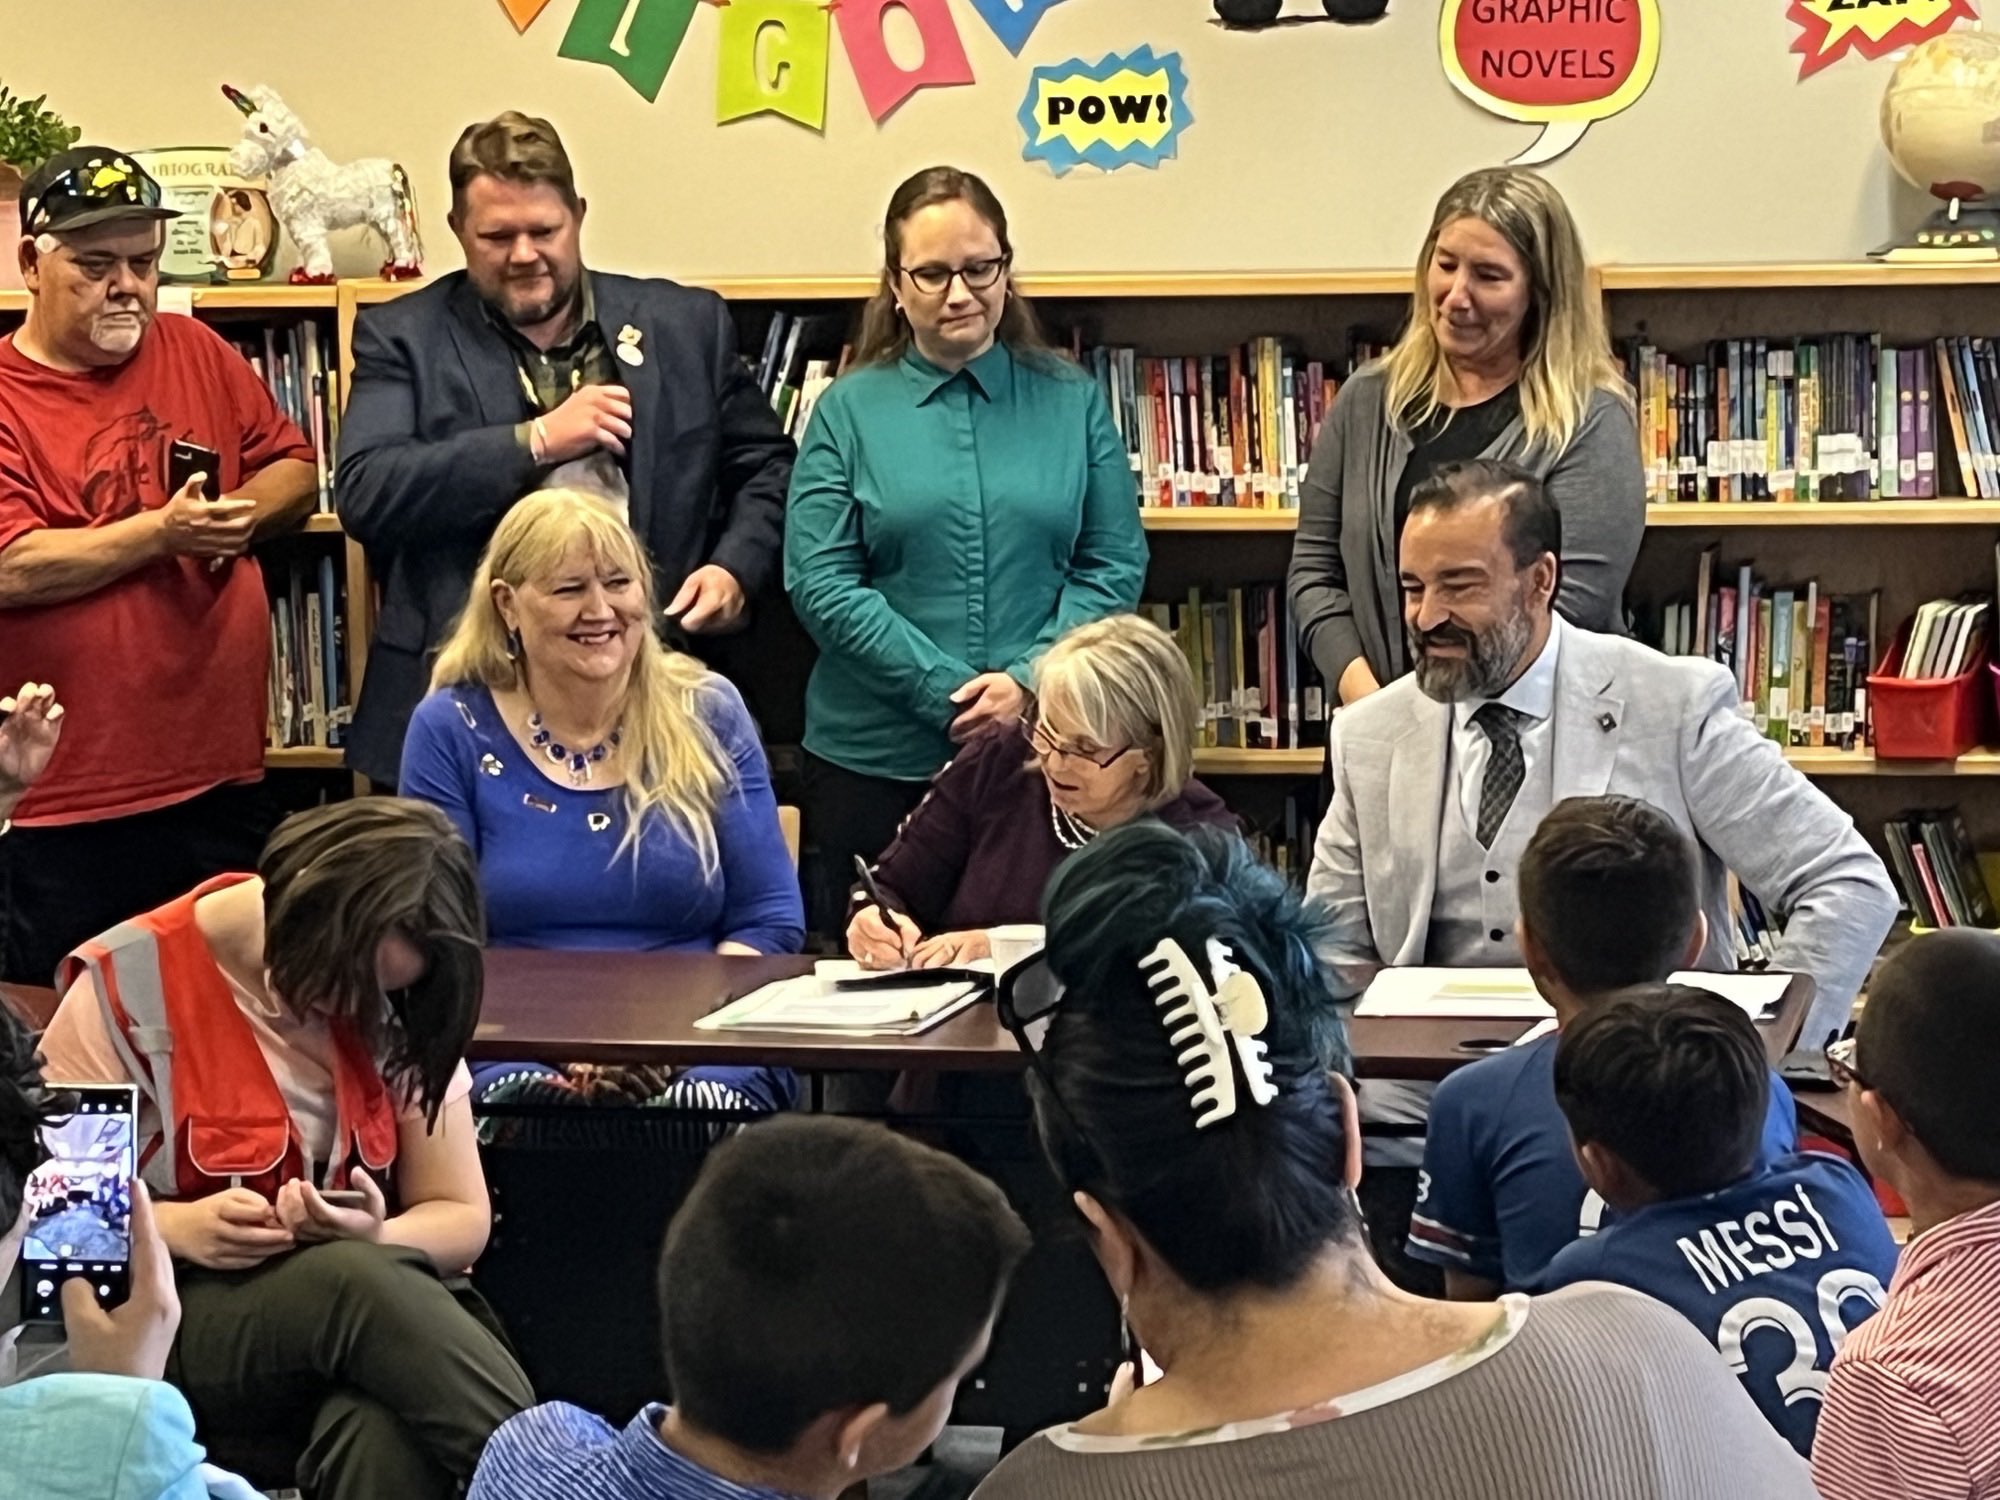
left=1408, top=796, right=1798, bottom=1300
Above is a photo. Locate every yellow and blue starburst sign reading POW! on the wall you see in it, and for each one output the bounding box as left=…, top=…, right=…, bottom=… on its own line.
left=1016, top=46, right=1194, bottom=176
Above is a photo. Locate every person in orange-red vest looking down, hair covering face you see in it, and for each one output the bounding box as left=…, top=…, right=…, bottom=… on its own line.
left=44, top=798, right=532, bottom=1500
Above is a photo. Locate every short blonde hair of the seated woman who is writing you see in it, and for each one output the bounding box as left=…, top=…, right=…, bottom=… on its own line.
left=1034, top=614, right=1202, bottom=808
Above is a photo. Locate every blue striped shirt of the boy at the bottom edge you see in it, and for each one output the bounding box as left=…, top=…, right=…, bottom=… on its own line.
left=468, top=1402, right=804, bottom=1500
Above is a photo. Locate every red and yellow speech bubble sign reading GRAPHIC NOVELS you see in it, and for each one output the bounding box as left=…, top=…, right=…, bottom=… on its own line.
left=1438, top=0, right=1660, bottom=166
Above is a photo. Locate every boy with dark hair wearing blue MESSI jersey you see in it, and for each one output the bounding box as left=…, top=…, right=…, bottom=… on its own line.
left=1546, top=984, right=1896, bottom=1454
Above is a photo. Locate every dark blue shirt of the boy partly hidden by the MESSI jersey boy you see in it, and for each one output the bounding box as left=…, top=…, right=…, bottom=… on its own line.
left=1408, top=1032, right=1798, bottom=1292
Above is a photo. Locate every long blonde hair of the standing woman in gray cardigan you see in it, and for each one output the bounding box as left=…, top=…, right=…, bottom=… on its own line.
left=1382, top=166, right=1632, bottom=452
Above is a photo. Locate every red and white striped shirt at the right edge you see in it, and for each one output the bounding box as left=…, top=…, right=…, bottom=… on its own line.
left=1812, top=1202, right=2000, bottom=1500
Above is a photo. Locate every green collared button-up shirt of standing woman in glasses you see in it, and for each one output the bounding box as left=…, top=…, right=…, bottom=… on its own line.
left=784, top=344, right=1146, bottom=780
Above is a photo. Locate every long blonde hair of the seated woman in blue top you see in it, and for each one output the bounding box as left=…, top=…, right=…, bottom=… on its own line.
left=430, top=490, right=734, bottom=874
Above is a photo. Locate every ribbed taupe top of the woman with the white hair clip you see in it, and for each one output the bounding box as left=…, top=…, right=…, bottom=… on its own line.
left=976, top=1282, right=1814, bottom=1500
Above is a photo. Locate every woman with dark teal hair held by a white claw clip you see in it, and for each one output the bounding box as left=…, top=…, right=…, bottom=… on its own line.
left=978, top=822, right=1812, bottom=1500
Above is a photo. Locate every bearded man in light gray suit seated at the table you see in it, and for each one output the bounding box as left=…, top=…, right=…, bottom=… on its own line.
left=1308, top=460, right=1896, bottom=1050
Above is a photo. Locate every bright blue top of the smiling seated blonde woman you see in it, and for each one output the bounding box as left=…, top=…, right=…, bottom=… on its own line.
left=400, top=678, right=806, bottom=954
